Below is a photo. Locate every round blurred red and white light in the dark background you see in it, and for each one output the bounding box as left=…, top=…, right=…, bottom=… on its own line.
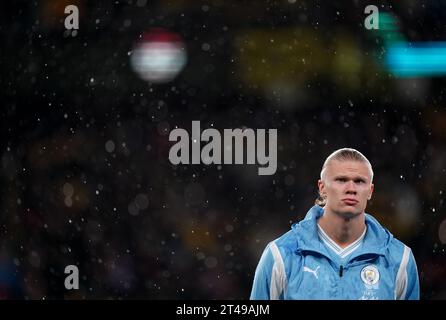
left=130, top=29, right=187, bottom=83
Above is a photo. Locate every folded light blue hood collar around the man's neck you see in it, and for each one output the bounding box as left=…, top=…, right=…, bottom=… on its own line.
left=292, top=205, right=393, bottom=260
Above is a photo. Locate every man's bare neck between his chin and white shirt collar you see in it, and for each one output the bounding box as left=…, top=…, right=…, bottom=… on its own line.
left=318, top=209, right=365, bottom=248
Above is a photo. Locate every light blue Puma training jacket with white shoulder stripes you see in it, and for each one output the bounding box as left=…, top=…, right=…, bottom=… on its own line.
left=250, top=205, right=420, bottom=300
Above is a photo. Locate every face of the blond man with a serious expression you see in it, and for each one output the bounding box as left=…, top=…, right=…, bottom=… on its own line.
left=318, top=160, right=373, bottom=218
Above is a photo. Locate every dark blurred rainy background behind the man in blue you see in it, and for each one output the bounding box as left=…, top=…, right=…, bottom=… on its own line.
left=0, top=0, right=446, bottom=299
